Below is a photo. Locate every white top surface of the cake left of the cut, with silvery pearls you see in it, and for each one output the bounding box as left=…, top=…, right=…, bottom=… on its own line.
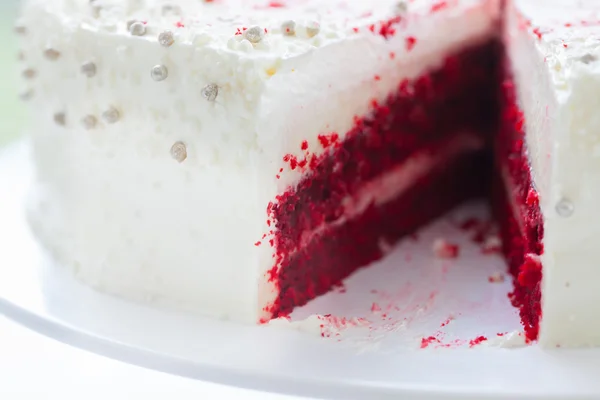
left=24, top=0, right=498, bottom=56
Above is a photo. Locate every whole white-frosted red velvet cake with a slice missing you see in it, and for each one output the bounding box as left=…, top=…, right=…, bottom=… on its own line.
left=17, top=0, right=600, bottom=346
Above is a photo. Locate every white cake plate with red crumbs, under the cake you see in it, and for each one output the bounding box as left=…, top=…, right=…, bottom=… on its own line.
left=0, top=143, right=600, bottom=400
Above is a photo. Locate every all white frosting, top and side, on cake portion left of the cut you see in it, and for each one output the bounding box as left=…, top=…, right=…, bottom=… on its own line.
left=20, top=0, right=498, bottom=322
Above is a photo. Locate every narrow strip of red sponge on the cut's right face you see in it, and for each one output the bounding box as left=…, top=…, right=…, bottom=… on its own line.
left=493, top=74, right=544, bottom=340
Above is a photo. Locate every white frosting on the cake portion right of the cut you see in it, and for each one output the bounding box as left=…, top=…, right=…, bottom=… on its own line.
left=506, top=0, right=600, bottom=346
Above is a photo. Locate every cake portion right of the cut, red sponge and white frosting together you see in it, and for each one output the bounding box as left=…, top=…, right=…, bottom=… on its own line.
left=504, top=0, right=600, bottom=346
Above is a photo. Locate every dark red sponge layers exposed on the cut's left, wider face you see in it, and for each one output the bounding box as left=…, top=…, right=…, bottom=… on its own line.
left=266, top=42, right=500, bottom=317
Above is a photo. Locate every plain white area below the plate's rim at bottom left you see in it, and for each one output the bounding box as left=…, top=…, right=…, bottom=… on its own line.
left=0, top=316, right=300, bottom=400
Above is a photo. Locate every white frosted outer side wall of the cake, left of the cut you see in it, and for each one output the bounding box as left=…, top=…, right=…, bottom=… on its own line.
left=23, top=3, right=269, bottom=321
